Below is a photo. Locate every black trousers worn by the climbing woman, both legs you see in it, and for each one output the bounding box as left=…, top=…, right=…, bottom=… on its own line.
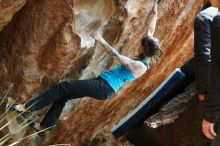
left=25, top=77, right=114, bottom=128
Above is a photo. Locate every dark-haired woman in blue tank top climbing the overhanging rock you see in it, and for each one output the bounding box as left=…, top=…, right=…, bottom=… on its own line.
left=8, top=0, right=162, bottom=136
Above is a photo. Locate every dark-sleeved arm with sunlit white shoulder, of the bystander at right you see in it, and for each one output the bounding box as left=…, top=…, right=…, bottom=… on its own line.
left=194, top=2, right=218, bottom=100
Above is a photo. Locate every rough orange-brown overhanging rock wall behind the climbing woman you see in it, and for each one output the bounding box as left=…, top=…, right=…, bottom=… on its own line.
left=0, top=0, right=208, bottom=146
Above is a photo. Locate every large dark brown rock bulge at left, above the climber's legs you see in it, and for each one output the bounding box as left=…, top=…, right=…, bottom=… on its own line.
left=0, top=1, right=80, bottom=100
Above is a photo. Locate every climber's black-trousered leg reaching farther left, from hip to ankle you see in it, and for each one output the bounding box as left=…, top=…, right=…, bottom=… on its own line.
left=25, top=78, right=114, bottom=112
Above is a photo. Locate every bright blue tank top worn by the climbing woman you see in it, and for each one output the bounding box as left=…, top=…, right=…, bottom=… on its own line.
left=100, top=60, right=150, bottom=92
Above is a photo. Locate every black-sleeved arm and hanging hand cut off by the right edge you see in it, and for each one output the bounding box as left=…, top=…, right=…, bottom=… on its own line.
left=202, top=10, right=220, bottom=146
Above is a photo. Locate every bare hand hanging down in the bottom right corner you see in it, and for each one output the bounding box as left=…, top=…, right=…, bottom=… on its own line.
left=202, top=119, right=217, bottom=139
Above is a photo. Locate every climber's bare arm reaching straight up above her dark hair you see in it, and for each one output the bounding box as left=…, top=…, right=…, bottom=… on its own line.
left=147, top=0, right=158, bottom=36
